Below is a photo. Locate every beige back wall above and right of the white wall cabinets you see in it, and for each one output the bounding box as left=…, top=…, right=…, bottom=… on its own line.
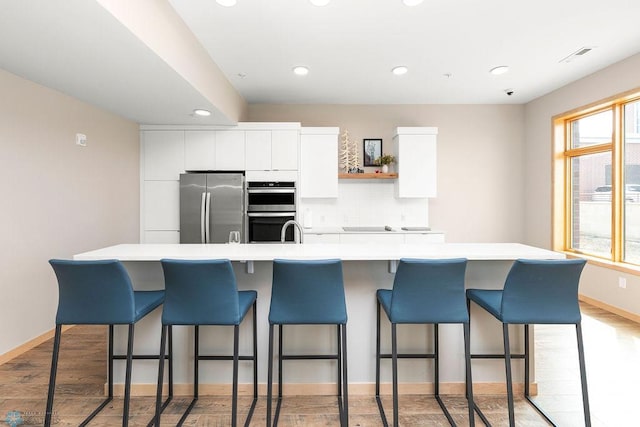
left=249, top=105, right=524, bottom=242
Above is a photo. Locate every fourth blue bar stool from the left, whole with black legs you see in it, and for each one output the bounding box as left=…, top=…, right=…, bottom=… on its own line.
left=376, top=258, right=475, bottom=427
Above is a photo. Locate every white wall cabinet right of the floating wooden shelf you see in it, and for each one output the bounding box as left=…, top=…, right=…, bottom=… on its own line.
left=393, top=127, right=438, bottom=198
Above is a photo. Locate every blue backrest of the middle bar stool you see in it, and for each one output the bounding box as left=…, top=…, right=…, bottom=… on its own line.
left=269, top=259, right=347, bottom=325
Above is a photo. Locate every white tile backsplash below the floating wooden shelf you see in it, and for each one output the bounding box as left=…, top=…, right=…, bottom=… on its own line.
left=298, top=180, right=429, bottom=227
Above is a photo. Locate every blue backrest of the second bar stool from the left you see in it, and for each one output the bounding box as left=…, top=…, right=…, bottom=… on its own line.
left=161, top=259, right=241, bottom=325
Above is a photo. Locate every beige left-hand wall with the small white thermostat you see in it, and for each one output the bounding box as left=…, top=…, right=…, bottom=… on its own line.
left=0, top=70, right=140, bottom=355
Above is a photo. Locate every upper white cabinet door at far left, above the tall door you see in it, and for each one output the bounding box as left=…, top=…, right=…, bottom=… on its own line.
left=141, top=130, right=184, bottom=181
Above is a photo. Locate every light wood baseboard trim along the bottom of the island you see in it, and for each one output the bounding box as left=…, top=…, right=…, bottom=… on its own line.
left=109, top=383, right=538, bottom=396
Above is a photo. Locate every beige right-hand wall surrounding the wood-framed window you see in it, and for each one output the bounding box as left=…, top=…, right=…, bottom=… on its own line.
left=524, top=54, right=640, bottom=314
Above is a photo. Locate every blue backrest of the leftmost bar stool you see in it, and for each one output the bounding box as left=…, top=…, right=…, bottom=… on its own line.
left=49, top=259, right=136, bottom=325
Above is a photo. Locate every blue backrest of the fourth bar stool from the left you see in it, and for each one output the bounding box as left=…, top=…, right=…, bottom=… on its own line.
left=390, top=258, right=469, bottom=323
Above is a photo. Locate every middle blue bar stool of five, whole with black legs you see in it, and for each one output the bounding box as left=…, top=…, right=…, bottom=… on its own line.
left=267, top=259, right=349, bottom=427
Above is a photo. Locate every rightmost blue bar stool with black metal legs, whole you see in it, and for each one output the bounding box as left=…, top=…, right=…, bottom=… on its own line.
left=467, top=259, right=591, bottom=426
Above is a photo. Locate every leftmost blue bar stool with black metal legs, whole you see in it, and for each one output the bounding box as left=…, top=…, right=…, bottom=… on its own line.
left=44, top=259, right=173, bottom=426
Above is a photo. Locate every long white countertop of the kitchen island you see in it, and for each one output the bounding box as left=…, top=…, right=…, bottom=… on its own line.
left=74, top=243, right=565, bottom=261
